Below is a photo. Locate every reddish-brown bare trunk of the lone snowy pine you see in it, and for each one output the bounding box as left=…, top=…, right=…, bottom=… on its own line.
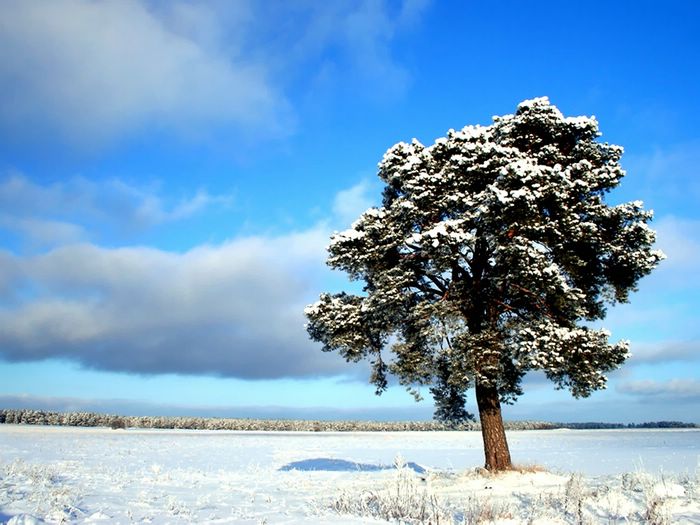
left=476, top=383, right=513, bottom=471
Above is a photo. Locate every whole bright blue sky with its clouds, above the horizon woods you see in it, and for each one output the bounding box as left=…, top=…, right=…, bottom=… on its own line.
left=0, top=0, right=700, bottom=422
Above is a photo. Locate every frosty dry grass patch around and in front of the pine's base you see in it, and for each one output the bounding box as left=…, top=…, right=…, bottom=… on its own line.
left=330, top=460, right=700, bottom=525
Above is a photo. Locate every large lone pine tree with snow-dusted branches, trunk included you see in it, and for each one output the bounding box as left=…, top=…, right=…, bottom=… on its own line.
left=305, top=98, right=663, bottom=470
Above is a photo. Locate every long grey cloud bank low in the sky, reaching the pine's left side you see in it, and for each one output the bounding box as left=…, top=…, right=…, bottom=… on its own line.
left=0, top=225, right=346, bottom=379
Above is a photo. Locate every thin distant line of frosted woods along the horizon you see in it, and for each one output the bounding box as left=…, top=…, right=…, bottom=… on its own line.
left=0, top=409, right=698, bottom=432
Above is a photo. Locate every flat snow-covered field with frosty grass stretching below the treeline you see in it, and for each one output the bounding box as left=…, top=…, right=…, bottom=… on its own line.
left=0, top=425, right=700, bottom=524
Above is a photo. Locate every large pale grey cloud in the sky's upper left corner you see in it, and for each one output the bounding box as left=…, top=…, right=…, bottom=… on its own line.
left=0, top=0, right=286, bottom=144
